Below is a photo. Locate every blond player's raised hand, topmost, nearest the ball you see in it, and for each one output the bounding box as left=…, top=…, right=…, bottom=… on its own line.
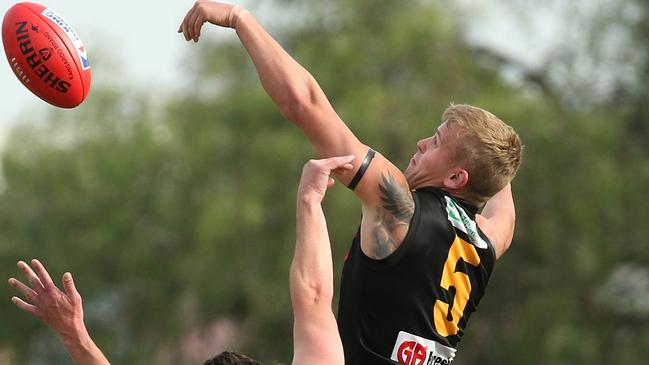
left=178, top=0, right=247, bottom=42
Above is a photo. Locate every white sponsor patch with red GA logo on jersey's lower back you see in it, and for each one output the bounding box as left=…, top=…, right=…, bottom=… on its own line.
left=390, top=331, right=456, bottom=365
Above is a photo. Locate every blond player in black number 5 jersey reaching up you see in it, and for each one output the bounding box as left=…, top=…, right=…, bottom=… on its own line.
left=178, top=1, right=522, bottom=365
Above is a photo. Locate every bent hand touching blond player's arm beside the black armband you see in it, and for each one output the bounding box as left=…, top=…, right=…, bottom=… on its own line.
left=298, top=155, right=354, bottom=202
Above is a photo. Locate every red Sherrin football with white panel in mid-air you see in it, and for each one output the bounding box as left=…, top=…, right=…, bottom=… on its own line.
left=2, top=2, right=91, bottom=108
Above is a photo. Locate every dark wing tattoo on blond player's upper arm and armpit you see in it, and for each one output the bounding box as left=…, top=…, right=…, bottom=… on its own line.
left=369, top=173, right=415, bottom=259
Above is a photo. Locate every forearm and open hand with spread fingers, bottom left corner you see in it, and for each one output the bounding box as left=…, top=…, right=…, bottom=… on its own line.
left=9, top=260, right=110, bottom=365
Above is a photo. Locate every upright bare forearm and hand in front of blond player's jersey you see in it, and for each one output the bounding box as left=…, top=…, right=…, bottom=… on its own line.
left=290, top=156, right=354, bottom=365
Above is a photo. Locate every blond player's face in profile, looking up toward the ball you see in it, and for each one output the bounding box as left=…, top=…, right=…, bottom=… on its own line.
left=404, top=122, right=457, bottom=189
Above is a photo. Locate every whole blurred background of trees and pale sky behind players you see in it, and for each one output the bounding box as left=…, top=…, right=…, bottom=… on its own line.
left=0, top=0, right=649, bottom=365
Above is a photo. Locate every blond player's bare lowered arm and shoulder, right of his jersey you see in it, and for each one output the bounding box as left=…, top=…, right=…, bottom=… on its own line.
left=476, top=184, right=516, bottom=258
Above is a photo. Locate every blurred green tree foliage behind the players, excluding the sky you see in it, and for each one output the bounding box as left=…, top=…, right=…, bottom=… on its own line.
left=0, top=0, right=649, bottom=364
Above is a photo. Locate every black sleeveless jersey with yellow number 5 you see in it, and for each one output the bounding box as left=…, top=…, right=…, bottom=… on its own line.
left=338, top=188, right=496, bottom=365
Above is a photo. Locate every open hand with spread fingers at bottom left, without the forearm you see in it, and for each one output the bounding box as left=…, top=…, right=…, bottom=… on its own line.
left=9, top=260, right=85, bottom=336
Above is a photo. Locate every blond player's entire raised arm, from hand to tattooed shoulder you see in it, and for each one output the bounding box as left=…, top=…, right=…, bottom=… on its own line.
left=178, top=0, right=413, bottom=258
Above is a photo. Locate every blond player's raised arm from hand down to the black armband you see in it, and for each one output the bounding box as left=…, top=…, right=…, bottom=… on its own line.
left=178, top=0, right=400, bottom=184
